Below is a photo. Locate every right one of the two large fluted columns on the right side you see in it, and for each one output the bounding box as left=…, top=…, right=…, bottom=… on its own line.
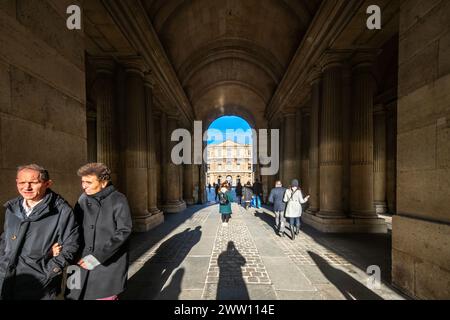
left=350, top=52, right=376, bottom=218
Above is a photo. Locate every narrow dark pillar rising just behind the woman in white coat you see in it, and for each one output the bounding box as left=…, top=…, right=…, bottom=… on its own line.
left=297, top=107, right=311, bottom=196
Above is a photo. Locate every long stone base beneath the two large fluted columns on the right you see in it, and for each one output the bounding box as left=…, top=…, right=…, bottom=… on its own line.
left=302, top=212, right=387, bottom=233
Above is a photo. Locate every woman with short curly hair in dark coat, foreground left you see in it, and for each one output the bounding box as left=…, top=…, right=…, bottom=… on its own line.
left=66, top=163, right=132, bottom=300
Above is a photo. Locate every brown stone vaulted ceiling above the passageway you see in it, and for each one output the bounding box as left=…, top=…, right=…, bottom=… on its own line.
left=142, top=0, right=320, bottom=127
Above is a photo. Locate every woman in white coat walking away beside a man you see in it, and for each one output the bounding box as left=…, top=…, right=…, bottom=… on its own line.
left=283, top=179, right=309, bottom=240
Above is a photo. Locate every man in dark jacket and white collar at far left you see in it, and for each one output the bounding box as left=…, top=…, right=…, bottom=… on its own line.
left=0, top=165, right=79, bottom=300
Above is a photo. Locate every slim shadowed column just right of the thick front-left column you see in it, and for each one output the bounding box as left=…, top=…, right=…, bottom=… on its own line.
left=145, top=73, right=164, bottom=228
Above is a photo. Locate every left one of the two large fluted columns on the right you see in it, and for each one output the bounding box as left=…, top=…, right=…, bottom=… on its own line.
left=318, top=53, right=345, bottom=218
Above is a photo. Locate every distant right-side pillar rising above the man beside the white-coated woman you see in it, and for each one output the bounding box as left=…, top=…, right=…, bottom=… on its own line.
left=282, top=112, right=299, bottom=187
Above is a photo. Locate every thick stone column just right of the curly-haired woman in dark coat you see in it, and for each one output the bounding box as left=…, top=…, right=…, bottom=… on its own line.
left=123, top=57, right=151, bottom=231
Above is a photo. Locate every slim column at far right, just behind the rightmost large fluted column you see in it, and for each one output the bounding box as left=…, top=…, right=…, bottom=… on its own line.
left=373, top=105, right=387, bottom=214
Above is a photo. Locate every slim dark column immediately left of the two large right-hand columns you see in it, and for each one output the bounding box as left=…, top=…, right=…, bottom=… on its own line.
left=308, top=68, right=322, bottom=214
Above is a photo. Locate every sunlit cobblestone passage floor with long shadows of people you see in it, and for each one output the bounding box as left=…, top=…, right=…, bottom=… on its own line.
left=123, top=195, right=404, bottom=300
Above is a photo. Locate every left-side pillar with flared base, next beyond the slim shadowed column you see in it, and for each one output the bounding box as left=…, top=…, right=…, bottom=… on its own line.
left=161, top=116, right=186, bottom=213
